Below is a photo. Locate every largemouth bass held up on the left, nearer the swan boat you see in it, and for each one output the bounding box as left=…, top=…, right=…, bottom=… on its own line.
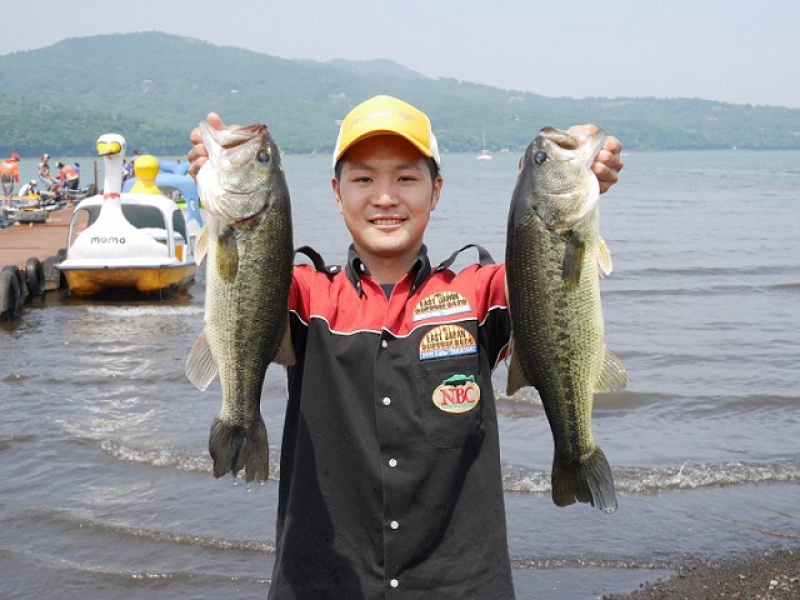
left=186, top=121, right=294, bottom=482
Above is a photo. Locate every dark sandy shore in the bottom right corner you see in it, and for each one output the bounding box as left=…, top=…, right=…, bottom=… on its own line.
left=603, top=549, right=800, bottom=600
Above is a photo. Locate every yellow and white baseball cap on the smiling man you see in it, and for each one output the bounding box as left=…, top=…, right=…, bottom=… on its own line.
left=333, top=96, right=442, bottom=167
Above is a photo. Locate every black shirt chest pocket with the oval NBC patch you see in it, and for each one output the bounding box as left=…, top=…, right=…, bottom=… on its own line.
left=415, top=355, right=485, bottom=448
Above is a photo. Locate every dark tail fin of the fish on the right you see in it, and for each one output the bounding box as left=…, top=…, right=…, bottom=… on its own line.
left=552, top=448, right=617, bottom=513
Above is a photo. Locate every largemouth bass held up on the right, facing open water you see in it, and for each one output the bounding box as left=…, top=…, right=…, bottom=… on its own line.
left=506, top=127, right=628, bottom=512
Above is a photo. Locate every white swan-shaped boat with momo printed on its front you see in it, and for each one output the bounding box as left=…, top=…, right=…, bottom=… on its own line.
left=58, top=134, right=197, bottom=296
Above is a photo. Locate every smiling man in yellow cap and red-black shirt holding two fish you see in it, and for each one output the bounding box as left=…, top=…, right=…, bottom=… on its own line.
left=189, top=96, right=622, bottom=600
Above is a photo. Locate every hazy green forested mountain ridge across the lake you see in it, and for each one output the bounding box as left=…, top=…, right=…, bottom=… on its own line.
left=0, top=32, right=800, bottom=156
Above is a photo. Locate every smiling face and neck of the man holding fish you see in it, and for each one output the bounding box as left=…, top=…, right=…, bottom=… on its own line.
left=332, top=135, right=442, bottom=265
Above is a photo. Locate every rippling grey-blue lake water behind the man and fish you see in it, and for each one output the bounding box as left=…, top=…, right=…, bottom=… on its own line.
left=0, top=151, right=800, bottom=600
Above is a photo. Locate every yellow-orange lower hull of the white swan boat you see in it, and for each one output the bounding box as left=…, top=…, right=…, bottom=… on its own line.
left=62, top=263, right=197, bottom=296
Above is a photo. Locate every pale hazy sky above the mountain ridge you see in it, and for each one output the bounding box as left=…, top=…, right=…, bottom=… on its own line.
left=6, top=0, right=800, bottom=108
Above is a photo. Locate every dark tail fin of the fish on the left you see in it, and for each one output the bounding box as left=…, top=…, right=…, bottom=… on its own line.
left=208, top=416, right=269, bottom=483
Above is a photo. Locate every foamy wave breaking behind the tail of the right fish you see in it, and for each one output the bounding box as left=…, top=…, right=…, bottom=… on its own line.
left=503, top=462, right=800, bottom=494
